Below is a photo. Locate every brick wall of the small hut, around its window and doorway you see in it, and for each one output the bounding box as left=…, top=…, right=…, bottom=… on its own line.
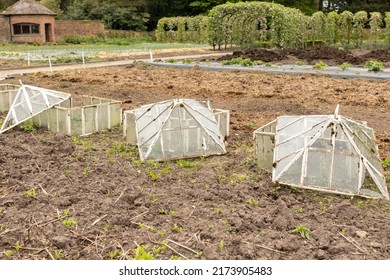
left=11, top=15, right=56, bottom=44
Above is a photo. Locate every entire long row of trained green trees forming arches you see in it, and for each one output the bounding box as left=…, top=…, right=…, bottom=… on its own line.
left=156, top=2, right=390, bottom=49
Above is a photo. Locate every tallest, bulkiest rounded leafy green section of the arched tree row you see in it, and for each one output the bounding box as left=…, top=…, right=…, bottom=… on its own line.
left=208, top=2, right=308, bottom=48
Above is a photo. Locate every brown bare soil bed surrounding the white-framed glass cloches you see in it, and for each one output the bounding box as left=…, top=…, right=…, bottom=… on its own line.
left=0, top=64, right=390, bottom=259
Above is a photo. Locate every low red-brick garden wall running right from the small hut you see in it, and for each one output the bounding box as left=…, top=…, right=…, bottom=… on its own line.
left=55, top=20, right=105, bottom=41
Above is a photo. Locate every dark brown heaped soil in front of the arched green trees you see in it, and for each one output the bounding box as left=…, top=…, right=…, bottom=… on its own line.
left=218, top=45, right=390, bottom=66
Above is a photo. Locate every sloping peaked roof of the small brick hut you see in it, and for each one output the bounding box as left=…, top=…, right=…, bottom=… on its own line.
left=1, top=0, right=56, bottom=16
